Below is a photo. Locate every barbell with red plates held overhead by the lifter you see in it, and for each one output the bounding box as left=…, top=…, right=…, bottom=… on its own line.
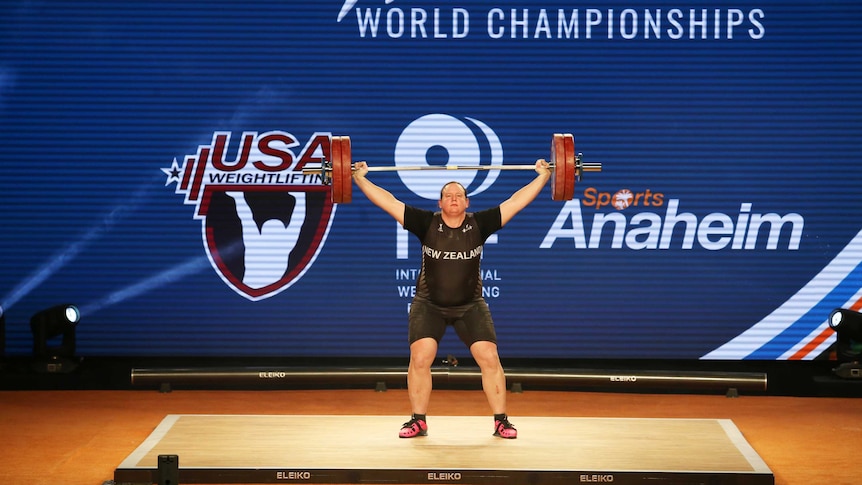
left=302, top=133, right=602, bottom=204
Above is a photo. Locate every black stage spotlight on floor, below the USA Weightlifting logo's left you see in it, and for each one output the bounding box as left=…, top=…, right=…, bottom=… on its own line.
left=30, top=304, right=81, bottom=372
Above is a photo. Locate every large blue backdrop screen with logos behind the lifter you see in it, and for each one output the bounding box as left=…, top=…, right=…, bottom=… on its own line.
left=0, top=0, right=862, bottom=360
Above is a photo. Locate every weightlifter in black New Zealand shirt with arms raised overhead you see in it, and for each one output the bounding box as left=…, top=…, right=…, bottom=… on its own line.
left=353, top=160, right=551, bottom=439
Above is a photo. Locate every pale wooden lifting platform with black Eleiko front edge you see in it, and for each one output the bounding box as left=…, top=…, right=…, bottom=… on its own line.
left=114, top=414, right=774, bottom=485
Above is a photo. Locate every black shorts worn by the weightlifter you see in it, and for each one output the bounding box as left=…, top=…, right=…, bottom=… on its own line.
left=407, top=299, right=497, bottom=347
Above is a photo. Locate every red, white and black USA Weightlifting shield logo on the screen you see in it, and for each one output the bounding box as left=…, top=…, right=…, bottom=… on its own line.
left=161, top=131, right=335, bottom=301
